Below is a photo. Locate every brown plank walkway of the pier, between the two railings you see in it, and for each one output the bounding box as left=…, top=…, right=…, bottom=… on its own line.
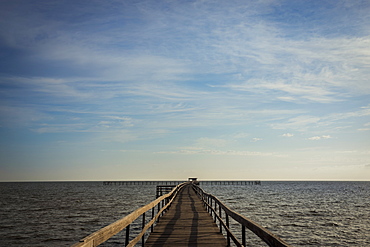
left=145, top=185, right=227, bottom=247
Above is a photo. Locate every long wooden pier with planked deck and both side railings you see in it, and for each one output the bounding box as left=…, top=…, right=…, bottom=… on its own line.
left=72, top=179, right=289, bottom=247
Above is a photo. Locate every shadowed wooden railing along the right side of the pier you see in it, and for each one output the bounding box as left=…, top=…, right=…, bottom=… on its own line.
left=193, top=184, right=290, bottom=247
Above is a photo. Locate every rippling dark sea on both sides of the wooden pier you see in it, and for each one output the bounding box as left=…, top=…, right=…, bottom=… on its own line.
left=0, top=182, right=370, bottom=246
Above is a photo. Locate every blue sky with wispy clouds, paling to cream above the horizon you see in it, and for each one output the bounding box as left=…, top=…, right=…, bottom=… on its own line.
left=0, top=0, right=370, bottom=181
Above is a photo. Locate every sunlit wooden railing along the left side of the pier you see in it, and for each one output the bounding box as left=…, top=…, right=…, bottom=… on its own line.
left=71, top=182, right=188, bottom=247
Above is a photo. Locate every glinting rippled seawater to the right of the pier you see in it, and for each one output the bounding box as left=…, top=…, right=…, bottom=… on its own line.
left=203, top=182, right=370, bottom=246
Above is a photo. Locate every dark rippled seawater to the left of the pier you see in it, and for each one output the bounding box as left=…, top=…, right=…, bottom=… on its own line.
left=0, top=182, right=155, bottom=246
